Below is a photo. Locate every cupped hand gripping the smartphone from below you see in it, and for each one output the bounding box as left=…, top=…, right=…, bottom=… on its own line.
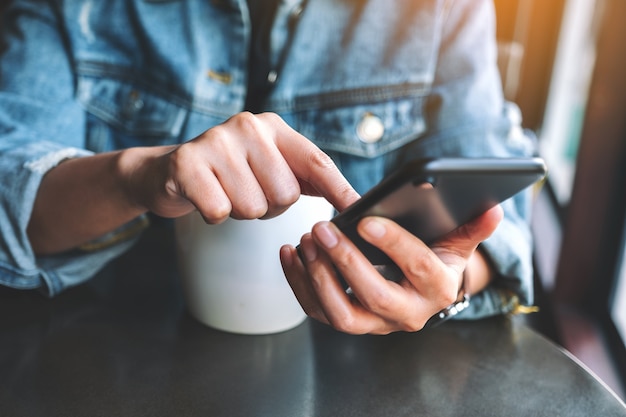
left=281, top=206, right=503, bottom=334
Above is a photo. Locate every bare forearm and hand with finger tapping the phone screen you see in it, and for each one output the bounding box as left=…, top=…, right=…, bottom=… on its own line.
left=28, top=113, right=358, bottom=254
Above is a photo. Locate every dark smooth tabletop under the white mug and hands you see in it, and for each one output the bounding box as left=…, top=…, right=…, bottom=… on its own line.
left=0, top=225, right=626, bottom=417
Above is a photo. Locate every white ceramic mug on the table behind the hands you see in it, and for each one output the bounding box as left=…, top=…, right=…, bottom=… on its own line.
left=175, top=196, right=333, bottom=334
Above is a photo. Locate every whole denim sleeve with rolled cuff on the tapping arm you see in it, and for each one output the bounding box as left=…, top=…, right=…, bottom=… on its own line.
left=0, top=1, right=144, bottom=296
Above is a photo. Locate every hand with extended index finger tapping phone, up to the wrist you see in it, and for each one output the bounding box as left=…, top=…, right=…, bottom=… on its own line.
left=124, top=109, right=358, bottom=223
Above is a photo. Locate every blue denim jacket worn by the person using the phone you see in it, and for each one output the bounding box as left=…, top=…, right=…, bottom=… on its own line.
left=0, top=0, right=534, bottom=317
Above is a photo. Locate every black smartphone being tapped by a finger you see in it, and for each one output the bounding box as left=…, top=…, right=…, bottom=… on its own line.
left=331, top=158, right=547, bottom=265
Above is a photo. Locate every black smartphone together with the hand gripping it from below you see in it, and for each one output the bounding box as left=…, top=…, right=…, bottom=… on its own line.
left=281, top=159, right=546, bottom=334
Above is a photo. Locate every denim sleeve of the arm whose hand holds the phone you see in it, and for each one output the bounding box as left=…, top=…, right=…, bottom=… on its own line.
left=404, top=0, right=536, bottom=318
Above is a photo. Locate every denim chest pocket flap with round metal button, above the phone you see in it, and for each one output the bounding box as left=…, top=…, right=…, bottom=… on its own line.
left=292, top=84, right=428, bottom=158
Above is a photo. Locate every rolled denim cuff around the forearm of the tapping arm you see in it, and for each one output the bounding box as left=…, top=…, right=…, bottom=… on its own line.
left=0, top=141, right=146, bottom=296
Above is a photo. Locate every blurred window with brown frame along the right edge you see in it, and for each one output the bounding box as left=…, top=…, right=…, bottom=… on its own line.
left=524, top=0, right=626, bottom=398
